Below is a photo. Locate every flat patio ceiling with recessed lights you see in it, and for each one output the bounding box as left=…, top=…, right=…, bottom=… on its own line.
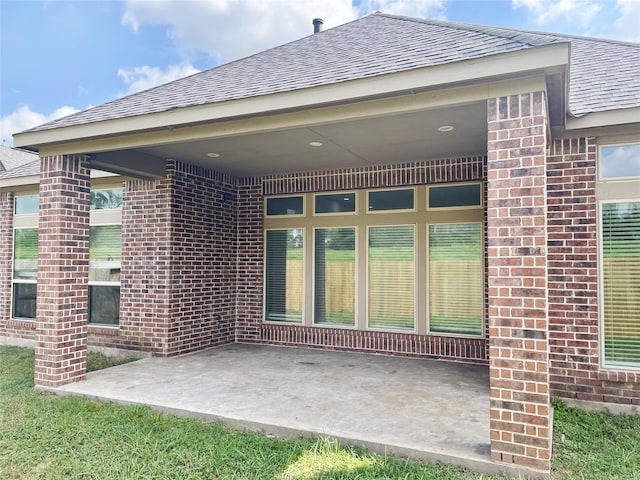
left=92, top=101, right=487, bottom=176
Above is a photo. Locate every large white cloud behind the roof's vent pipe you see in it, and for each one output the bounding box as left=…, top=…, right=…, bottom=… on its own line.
left=122, top=0, right=356, bottom=62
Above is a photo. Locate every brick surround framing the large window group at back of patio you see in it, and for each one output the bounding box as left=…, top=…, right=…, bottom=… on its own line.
left=236, top=156, right=487, bottom=363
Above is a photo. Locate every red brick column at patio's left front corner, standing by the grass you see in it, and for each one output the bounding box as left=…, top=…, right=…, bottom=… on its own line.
left=35, top=155, right=90, bottom=387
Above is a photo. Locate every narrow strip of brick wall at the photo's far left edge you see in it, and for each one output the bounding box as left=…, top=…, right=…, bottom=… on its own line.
left=0, top=192, right=13, bottom=322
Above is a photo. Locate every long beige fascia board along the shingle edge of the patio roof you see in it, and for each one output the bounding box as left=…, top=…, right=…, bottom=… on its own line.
left=14, top=42, right=570, bottom=149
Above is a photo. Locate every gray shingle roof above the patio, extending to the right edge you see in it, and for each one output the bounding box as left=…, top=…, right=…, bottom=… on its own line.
left=21, top=13, right=640, bottom=131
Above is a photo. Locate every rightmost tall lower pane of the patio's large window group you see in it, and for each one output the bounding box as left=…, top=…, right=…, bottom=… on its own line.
left=429, top=223, right=484, bottom=335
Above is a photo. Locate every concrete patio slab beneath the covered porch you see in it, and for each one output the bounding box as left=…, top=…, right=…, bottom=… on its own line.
left=55, top=344, right=500, bottom=473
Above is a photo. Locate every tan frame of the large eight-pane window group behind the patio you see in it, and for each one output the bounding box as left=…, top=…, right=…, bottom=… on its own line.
left=262, top=184, right=487, bottom=339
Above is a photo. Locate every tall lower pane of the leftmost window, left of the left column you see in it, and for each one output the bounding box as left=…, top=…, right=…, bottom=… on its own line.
left=12, top=228, right=38, bottom=319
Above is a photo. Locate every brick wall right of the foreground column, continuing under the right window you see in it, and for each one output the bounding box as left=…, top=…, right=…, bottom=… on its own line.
left=547, top=137, right=640, bottom=405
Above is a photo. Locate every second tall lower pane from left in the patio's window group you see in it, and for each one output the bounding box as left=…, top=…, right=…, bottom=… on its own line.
left=313, top=227, right=356, bottom=326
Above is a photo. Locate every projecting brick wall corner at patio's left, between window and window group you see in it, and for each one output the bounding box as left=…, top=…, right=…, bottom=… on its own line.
left=90, top=161, right=237, bottom=355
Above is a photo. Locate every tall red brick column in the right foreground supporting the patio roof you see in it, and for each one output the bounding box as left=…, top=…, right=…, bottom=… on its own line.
left=487, top=92, right=552, bottom=472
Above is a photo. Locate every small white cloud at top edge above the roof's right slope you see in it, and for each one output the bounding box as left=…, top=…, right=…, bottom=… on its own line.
left=511, top=0, right=602, bottom=28
